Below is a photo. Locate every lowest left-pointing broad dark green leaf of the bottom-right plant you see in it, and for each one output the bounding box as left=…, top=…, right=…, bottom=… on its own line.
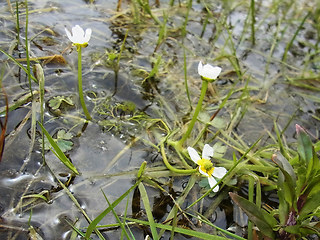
left=229, top=192, right=278, bottom=239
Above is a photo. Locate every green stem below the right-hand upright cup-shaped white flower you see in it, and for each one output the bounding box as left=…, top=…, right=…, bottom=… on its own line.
left=175, top=80, right=208, bottom=150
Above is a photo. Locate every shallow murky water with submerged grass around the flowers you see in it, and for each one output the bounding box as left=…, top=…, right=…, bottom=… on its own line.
left=0, top=0, right=320, bottom=239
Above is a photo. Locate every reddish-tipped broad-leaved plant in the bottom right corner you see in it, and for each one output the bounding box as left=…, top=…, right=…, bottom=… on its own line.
left=230, top=125, right=320, bottom=239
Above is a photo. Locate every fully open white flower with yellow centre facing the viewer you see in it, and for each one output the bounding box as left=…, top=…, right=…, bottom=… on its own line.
left=188, top=144, right=227, bottom=192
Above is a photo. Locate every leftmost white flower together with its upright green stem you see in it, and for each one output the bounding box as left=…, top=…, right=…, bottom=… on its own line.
left=65, top=25, right=92, bottom=120
